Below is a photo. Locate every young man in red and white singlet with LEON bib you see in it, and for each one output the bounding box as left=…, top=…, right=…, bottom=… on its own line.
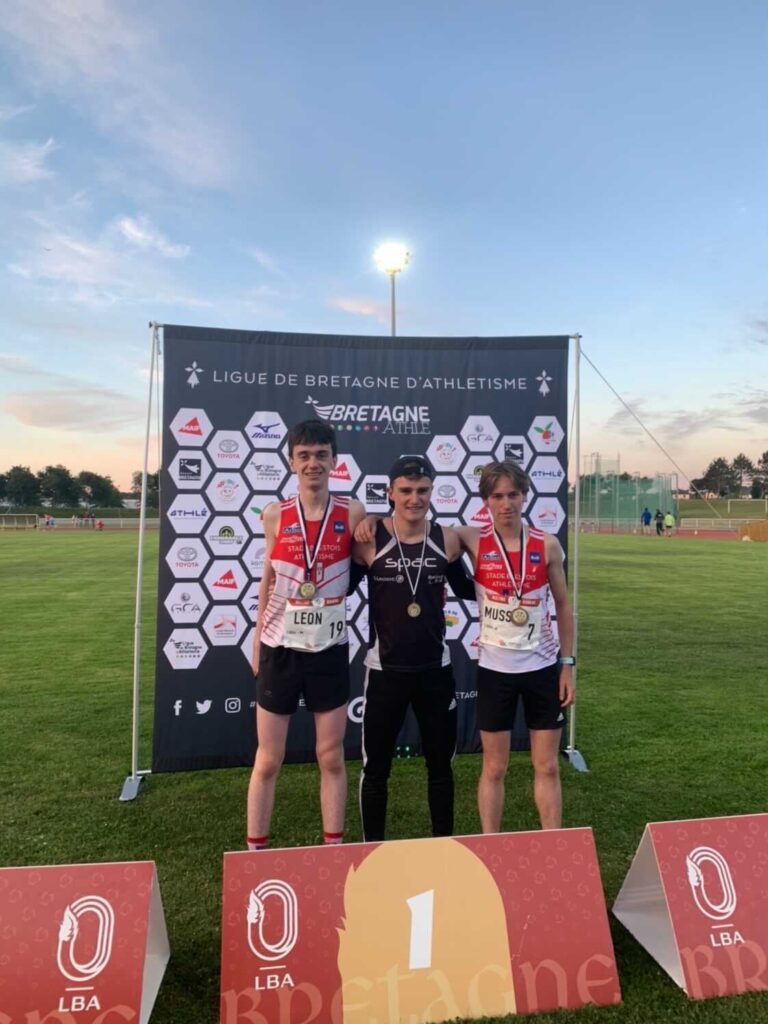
left=248, top=420, right=366, bottom=850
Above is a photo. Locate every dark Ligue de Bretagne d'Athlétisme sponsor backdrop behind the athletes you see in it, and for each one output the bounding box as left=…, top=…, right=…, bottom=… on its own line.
left=153, top=326, right=568, bottom=771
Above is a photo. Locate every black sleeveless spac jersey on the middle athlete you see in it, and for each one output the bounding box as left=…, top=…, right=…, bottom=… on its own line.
left=366, top=519, right=451, bottom=672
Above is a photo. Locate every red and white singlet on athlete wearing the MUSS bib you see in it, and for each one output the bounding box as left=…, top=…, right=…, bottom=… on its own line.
left=475, top=523, right=558, bottom=673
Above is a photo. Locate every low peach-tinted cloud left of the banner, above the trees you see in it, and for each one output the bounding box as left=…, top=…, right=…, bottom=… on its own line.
left=1, top=387, right=142, bottom=433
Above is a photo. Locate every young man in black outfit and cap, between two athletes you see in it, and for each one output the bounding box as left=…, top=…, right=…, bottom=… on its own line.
left=353, top=456, right=461, bottom=842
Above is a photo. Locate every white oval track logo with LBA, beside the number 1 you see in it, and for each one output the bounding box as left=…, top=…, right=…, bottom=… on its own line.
left=246, top=879, right=299, bottom=990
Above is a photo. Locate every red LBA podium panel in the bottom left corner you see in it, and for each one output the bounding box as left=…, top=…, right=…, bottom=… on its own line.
left=0, top=861, right=169, bottom=1024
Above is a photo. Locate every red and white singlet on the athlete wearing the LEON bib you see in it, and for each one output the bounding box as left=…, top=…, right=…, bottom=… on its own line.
left=261, top=495, right=352, bottom=647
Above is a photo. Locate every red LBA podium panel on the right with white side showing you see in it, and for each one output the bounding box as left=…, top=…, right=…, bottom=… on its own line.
left=613, top=814, right=768, bottom=999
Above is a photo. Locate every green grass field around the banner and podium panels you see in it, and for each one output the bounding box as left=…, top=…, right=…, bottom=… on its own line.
left=0, top=531, right=768, bottom=1024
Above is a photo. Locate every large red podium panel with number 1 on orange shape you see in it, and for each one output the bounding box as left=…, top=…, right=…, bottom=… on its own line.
left=221, top=828, right=621, bottom=1024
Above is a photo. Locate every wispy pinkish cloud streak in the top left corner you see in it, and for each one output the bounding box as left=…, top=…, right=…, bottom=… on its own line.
left=2, top=0, right=232, bottom=186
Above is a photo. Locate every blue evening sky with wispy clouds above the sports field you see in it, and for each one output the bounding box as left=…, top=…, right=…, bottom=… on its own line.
left=0, top=0, right=768, bottom=486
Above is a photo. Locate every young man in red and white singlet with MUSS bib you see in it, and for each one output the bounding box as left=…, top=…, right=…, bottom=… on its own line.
left=457, top=461, right=575, bottom=833
